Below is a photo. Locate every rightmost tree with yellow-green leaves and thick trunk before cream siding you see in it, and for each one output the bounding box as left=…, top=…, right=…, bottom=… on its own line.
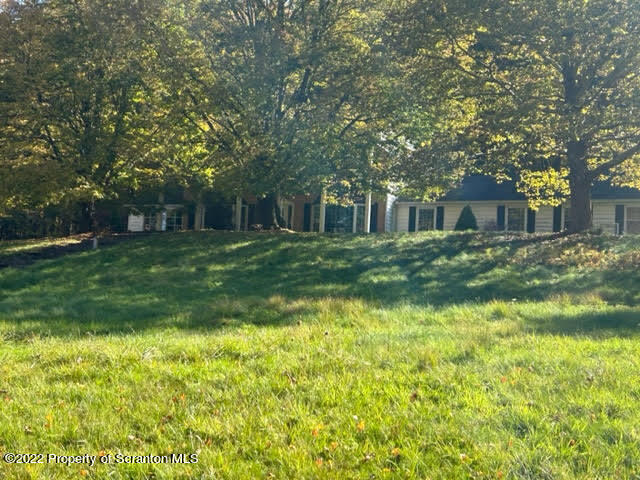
left=392, top=0, right=640, bottom=231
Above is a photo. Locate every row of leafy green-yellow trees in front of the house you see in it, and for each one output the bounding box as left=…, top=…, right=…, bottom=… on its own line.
left=0, top=0, right=640, bottom=236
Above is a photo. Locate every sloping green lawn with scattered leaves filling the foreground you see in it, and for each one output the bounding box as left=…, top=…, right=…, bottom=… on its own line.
left=0, top=232, right=640, bottom=479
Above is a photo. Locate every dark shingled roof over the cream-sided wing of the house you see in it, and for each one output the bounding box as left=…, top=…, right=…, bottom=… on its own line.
left=398, top=175, right=640, bottom=202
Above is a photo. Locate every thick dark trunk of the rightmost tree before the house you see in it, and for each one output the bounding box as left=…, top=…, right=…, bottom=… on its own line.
left=567, top=141, right=592, bottom=233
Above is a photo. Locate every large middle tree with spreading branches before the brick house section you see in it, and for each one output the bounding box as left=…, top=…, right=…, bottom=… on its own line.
left=159, top=0, right=404, bottom=227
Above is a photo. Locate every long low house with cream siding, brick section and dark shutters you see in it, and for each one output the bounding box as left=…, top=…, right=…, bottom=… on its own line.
left=128, top=175, right=640, bottom=234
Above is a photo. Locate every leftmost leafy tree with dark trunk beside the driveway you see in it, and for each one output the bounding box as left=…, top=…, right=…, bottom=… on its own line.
left=0, top=0, right=169, bottom=231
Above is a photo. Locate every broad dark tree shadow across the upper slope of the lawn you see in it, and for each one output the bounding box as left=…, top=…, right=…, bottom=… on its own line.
left=0, top=233, right=640, bottom=336
